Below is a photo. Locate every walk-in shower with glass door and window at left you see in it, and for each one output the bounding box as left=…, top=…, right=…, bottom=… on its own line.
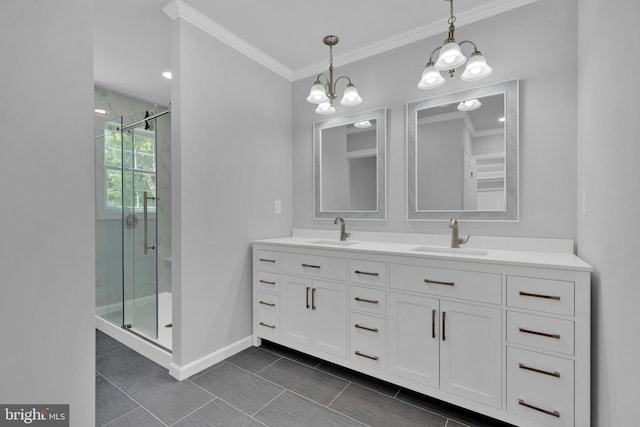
left=94, top=90, right=172, bottom=362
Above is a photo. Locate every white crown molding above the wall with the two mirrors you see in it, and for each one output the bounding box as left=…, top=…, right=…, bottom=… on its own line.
left=293, top=0, right=538, bottom=81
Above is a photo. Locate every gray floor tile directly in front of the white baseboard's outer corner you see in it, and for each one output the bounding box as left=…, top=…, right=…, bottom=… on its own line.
left=123, top=371, right=215, bottom=424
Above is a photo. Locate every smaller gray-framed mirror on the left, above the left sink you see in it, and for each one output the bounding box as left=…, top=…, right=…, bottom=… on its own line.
left=313, top=108, right=387, bottom=219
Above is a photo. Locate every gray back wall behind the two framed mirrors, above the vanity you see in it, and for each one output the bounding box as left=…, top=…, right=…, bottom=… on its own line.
left=293, top=0, right=577, bottom=239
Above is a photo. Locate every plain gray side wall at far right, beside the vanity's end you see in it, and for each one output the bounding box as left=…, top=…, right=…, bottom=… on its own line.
left=577, top=0, right=640, bottom=427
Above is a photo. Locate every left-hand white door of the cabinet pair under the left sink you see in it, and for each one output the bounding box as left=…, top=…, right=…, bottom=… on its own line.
left=280, top=276, right=312, bottom=346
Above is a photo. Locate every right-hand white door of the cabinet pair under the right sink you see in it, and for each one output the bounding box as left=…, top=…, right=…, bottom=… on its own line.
left=440, top=301, right=502, bottom=408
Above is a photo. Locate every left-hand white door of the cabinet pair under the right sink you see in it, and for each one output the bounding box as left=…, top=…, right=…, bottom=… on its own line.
left=388, top=292, right=440, bottom=387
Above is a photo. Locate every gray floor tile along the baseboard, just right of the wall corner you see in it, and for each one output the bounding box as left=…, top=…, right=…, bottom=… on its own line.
left=191, top=362, right=283, bottom=414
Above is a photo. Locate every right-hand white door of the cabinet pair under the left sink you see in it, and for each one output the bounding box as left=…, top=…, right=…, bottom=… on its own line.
left=311, top=280, right=347, bottom=357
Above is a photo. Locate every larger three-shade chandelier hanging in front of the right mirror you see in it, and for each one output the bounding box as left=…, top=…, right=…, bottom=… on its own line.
left=418, top=0, right=493, bottom=89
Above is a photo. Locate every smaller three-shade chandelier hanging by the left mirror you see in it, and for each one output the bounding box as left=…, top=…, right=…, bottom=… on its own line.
left=307, top=36, right=362, bottom=114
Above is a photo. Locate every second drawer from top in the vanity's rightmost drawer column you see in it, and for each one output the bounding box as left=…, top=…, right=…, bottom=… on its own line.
left=507, top=311, right=574, bottom=354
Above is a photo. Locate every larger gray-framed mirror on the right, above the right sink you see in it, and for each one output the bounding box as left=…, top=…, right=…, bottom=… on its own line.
left=407, top=80, right=519, bottom=221
